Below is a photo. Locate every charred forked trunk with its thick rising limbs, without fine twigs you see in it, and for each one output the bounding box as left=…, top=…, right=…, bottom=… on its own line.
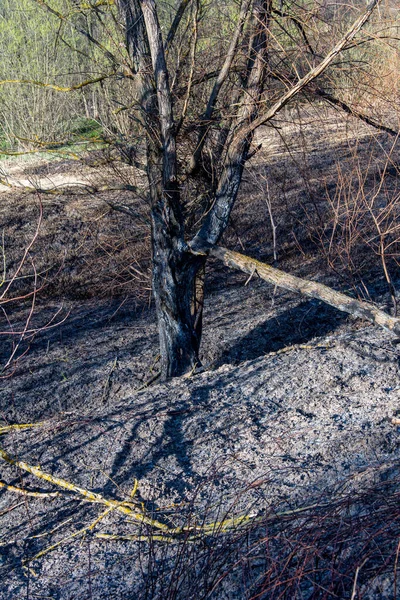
left=118, top=0, right=396, bottom=378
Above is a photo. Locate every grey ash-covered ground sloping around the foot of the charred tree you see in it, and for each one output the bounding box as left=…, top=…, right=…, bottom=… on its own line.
left=0, top=282, right=400, bottom=599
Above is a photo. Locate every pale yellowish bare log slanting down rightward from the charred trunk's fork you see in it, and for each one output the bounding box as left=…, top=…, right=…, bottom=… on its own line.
left=208, top=246, right=400, bottom=336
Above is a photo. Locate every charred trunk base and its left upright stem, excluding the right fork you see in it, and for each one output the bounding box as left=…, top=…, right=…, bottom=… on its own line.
left=119, top=0, right=205, bottom=380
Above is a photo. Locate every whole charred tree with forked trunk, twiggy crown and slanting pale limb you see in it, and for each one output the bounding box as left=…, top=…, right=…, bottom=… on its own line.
left=3, top=0, right=400, bottom=379
